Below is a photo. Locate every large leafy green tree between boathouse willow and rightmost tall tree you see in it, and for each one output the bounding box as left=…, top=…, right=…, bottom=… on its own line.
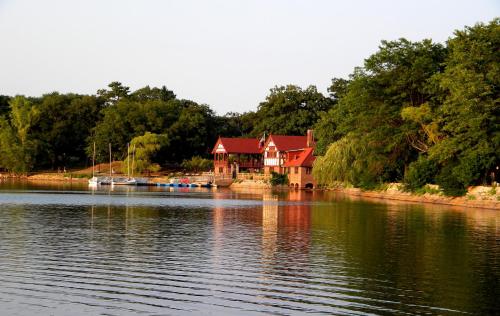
left=316, top=39, right=446, bottom=186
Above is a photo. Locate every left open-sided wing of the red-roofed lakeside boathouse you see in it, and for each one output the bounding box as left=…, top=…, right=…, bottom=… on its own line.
left=212, top=137, right=262, bottom=178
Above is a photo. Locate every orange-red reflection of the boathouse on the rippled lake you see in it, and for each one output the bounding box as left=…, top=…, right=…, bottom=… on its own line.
left=212, top=191, right=311, bottom=275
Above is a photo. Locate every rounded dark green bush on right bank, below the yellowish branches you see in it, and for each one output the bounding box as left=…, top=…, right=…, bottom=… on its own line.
left=403, top=156, right=438, bottom=192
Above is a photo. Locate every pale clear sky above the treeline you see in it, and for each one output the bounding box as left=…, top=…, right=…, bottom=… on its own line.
left=0, top=0, right=500, bottom=114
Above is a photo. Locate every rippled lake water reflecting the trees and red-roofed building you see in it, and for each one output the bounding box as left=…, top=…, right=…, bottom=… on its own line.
left=0, top=182, right=500, bottom=315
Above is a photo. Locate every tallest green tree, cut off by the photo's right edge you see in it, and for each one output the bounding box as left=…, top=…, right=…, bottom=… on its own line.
left=429, top=18, right=500, bottom=188
